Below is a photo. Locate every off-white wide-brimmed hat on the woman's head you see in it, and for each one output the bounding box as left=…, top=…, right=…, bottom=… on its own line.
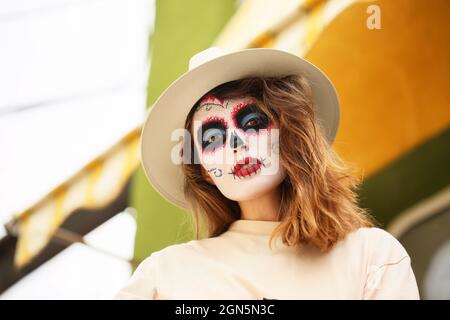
left=141, top=47, right=339, bottom=209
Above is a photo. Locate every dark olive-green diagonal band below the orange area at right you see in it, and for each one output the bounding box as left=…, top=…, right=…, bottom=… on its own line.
left=360, top=128, right=450, bottom=226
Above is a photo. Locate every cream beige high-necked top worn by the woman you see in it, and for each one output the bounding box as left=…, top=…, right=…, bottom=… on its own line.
left=114, top=220, right=419, bottom=300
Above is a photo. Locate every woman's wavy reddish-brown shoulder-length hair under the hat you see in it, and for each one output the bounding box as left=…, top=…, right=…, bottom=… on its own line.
left=182, top=75, right=375, bottom=252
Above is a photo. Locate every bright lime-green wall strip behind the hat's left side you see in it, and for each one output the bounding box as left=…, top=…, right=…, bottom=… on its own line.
left=130, top=0, right=237, bottom=261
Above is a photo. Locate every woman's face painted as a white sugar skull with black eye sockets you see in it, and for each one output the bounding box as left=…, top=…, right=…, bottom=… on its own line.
left=191, top=96, right=286, bottom=201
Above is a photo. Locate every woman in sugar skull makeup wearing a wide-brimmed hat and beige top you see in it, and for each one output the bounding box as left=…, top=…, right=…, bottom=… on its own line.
left=116, top=48, right=419, bottom=299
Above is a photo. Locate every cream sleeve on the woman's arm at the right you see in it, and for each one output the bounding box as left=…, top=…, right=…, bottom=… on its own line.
left=364, top=228, right=420, bottom=300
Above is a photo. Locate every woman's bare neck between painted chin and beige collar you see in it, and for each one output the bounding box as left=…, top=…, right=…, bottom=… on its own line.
left=239, top=188, right=280, bottom=221
